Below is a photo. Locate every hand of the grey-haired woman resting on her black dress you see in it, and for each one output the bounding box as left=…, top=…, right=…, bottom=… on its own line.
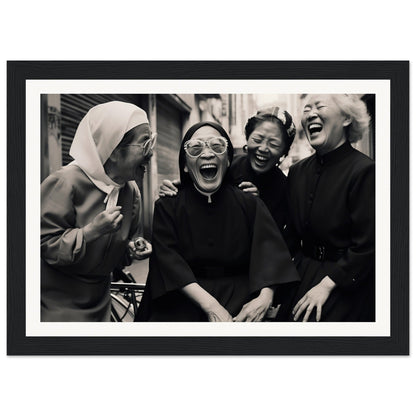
left=292, top=276, right=335, bottom=322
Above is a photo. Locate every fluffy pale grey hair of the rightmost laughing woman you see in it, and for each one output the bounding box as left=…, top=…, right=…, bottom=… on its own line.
left=331, top=94, right=370, bottom=143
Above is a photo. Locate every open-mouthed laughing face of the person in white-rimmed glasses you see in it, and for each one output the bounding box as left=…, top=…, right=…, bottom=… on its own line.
left=184, top=126, right=230, bottom=193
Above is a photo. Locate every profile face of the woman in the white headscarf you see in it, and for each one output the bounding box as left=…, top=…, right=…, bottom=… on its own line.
left=109, top=124, right=153, bottom=182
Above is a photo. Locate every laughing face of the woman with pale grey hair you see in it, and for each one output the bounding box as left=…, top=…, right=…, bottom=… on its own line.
left=302, top=94, right=351, bottom=154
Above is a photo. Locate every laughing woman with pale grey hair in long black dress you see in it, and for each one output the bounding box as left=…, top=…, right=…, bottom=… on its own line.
left=282, top=94, right=375, bottom=322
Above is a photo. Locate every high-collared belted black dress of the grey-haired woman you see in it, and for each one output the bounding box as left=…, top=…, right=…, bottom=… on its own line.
left=282, top=142, right=375, bottom=322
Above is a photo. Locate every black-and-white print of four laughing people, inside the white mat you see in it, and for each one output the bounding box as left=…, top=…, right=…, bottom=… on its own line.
left=40, top=93, right=376, bottom=324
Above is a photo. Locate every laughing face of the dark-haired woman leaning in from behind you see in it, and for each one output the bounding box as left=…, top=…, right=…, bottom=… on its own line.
left=247, top=121, right=285, bottom=173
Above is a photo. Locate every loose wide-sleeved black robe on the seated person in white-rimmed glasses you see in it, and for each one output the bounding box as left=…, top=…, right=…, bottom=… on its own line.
left=138, top=184, right=299, bottom=321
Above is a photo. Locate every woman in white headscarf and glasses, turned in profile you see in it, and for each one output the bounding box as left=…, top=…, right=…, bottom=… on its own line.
left=41, top=101, right=154, bottom=322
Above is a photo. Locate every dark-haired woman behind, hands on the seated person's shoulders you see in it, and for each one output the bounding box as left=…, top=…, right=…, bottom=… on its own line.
left=160, top=107, right=296, bottom=231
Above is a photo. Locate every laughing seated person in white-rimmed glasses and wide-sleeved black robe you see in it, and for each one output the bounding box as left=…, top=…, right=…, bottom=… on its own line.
left=138, top=122, right=299, bottom=322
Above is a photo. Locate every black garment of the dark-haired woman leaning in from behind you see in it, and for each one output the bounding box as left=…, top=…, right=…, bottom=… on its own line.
left=229, top=155, right=289, bottom=232
